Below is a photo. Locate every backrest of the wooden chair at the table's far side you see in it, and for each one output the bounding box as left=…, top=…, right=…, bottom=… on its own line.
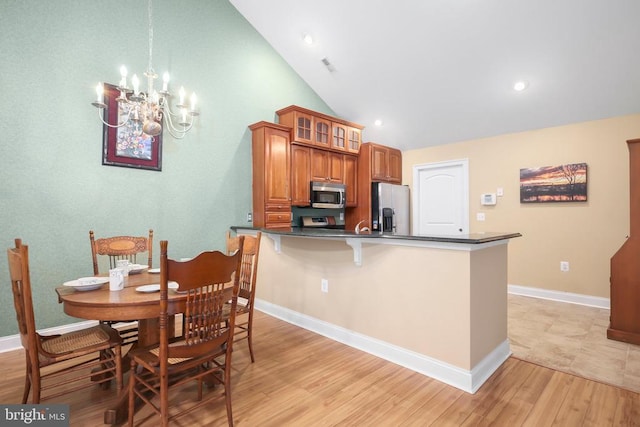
left=89, top=229, right=153, bottom=276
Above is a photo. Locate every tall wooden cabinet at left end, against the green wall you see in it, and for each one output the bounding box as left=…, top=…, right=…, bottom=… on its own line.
left=249, top=121, right=291, bottom=228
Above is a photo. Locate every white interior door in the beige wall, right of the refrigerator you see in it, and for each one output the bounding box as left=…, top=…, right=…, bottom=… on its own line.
left=412, top=159, right=469, bottom=235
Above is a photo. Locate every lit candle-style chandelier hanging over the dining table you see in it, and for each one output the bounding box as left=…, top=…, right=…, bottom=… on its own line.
left=91, top=0, right=199, bottom=139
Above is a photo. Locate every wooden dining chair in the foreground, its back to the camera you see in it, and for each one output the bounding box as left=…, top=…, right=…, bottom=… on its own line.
left=129, top=238, right=244, bottom=427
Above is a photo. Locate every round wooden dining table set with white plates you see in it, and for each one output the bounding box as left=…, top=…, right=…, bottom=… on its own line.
left=56, top=271, right=187, bottom=424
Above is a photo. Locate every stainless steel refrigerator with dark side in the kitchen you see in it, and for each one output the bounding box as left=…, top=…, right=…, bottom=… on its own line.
left=371, top=182, right=409, bottom=236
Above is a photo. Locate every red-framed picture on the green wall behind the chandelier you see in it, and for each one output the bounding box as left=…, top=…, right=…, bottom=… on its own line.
left=102, top=83, right=162, bottom=171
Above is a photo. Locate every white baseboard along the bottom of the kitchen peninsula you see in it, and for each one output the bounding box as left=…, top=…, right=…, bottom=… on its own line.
left=255, top=299, right=511, bottom=393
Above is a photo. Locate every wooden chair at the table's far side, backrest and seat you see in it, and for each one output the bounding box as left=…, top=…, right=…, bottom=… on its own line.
left=89, top=229, right=153, bottom=345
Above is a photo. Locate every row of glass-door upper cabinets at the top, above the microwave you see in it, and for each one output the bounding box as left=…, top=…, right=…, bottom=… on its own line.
left=276, top=105, right=363, bottom=154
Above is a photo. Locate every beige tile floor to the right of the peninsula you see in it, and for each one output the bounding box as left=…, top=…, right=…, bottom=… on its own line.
left=508, top=294, right=640, bottom=393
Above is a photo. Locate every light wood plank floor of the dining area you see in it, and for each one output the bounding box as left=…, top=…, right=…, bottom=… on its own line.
left=0, top=313, right=640, bottom=427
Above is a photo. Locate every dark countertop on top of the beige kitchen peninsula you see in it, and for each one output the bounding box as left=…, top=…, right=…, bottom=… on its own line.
left=231, top=226, right=522, bottom=244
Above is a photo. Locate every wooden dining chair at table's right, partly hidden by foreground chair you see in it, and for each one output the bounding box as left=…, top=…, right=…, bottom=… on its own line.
left=225, top=231, right=262, bottom=363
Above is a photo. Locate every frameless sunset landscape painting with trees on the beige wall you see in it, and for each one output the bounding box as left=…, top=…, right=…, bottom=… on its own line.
left=520, top=163, right=587, bottom=203
